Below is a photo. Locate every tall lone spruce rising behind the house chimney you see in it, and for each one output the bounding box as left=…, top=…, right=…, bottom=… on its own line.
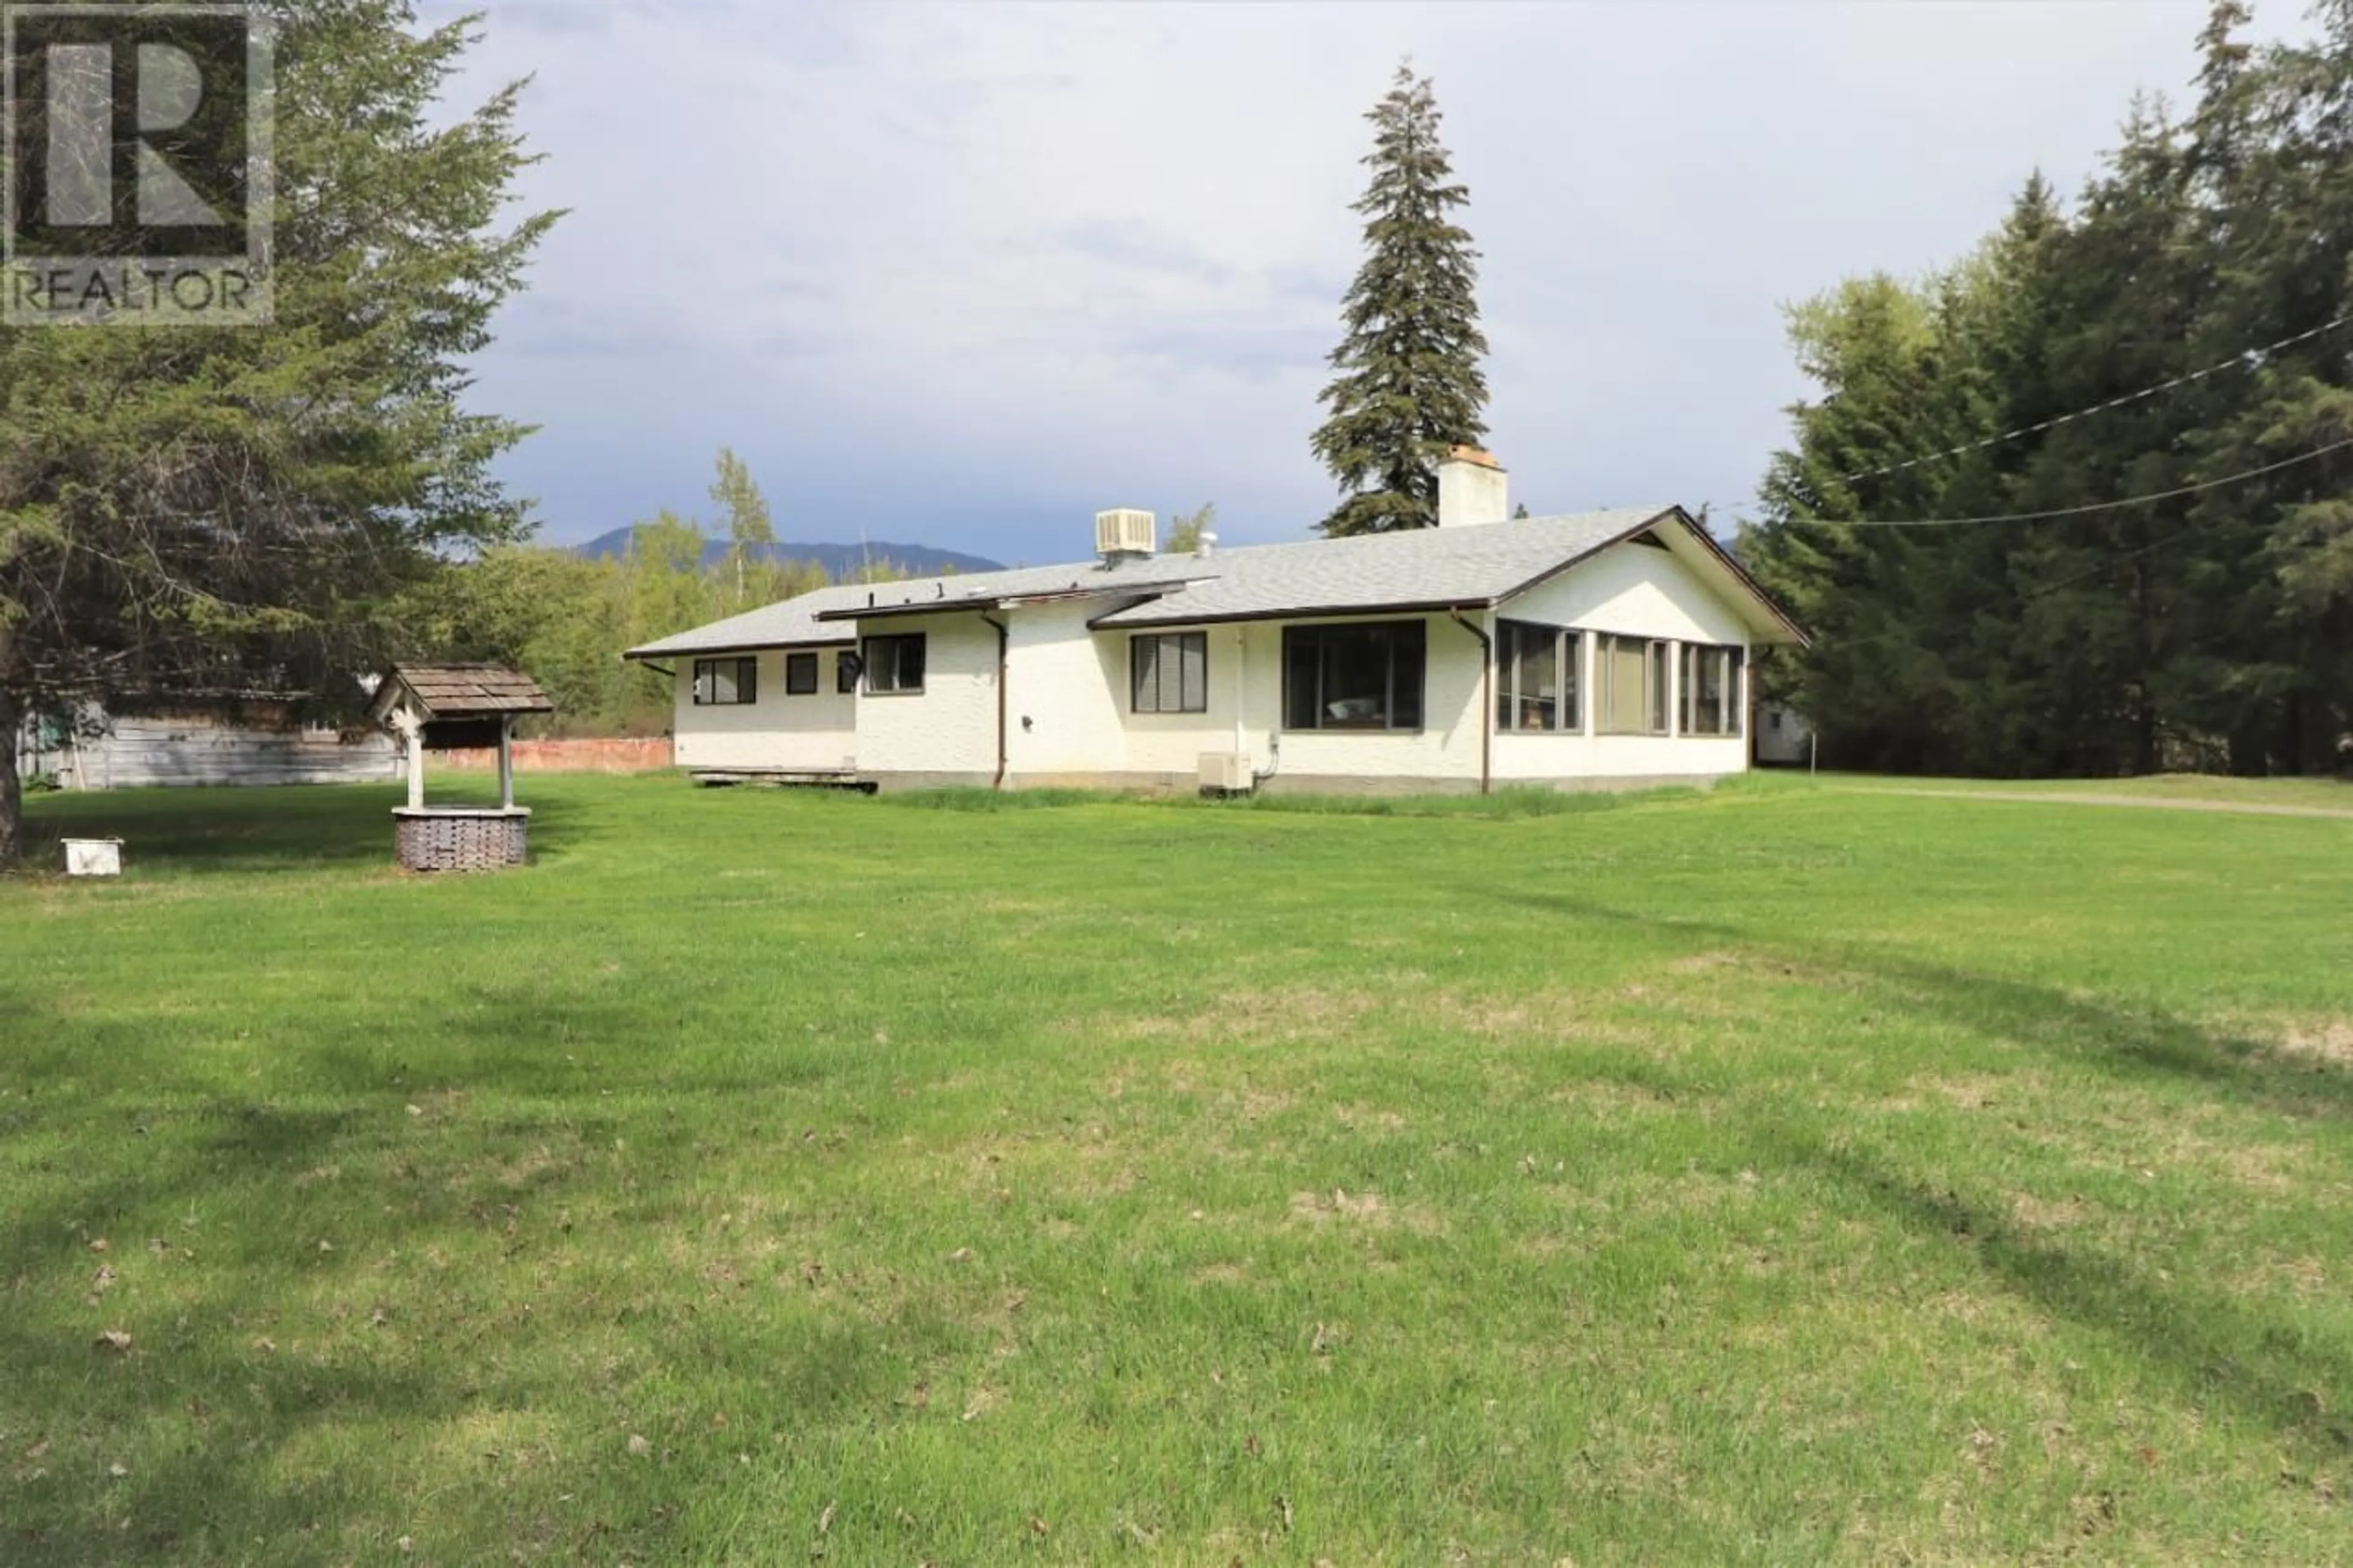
left=1311, top=66, right=1487, bottom=537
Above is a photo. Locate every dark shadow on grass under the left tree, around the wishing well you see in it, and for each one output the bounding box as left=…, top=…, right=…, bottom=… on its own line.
left=23, top=784, right=581, bottom=876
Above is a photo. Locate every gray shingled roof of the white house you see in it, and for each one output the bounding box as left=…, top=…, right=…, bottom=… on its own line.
left=628, top=506, right=1769, bottom=659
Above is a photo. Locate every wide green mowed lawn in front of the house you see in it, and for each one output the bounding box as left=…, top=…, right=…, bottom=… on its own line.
left=0, top=777, right=2353, bottom=1566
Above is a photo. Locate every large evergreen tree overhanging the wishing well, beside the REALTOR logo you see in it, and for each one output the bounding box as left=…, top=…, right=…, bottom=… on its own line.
left=0, top=0, right=553, bottom=862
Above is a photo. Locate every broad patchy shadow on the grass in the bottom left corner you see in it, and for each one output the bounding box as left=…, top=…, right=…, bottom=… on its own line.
left=0, top=1021, right=922, bottom=1566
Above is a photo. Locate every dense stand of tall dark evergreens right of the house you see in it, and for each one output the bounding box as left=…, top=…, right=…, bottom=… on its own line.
left=1741, top=0, right=2353, bottom=775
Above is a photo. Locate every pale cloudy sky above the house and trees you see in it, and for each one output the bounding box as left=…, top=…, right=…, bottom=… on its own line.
left=426, top=0, right=2299, bottom=562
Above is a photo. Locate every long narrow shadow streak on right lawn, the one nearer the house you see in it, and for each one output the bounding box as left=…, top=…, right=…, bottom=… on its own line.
left=1485, top=888, right=2353, bottom=1118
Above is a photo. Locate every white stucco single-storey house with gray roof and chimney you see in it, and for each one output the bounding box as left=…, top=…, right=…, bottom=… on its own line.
left=626, top=447, right=1802, bottom=791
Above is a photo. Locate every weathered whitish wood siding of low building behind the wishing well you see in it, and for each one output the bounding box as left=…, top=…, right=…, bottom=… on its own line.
left=42, top=718, right=400, bottom=789
